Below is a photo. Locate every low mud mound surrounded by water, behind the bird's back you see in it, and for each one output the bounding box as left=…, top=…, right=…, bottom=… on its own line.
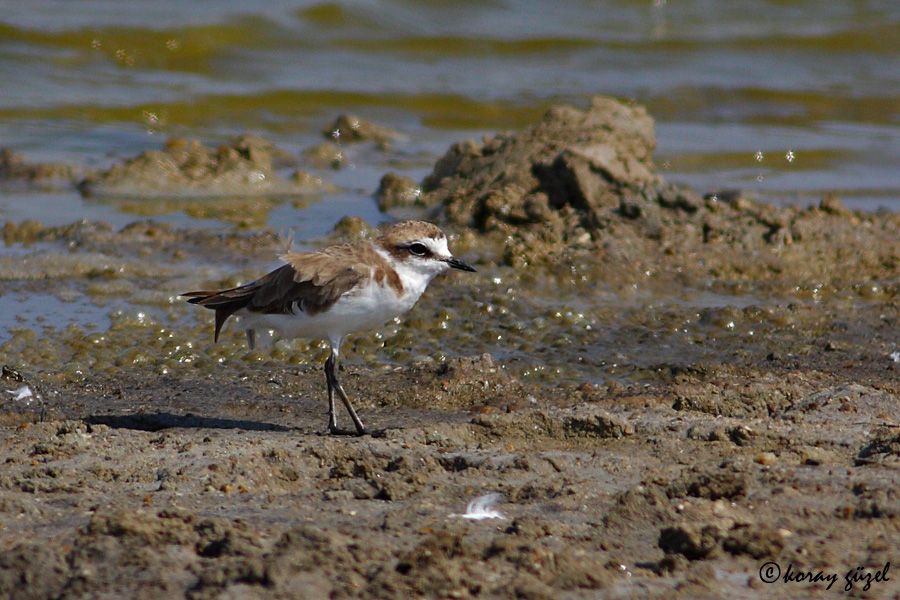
left=79, top=136, right=323, bottom=197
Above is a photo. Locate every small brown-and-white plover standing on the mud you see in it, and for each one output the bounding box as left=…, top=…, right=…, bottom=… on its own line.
left=182, top=221, right=475, bottom=435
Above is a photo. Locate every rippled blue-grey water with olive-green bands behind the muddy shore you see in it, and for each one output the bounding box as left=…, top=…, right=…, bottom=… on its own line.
left=0, top=0, right=900, bottom=364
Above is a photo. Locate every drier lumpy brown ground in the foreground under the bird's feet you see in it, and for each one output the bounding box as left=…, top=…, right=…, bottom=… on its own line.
left=0, top=330, right=900, bottom=598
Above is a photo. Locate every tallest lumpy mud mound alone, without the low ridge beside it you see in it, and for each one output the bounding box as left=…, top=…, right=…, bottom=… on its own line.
left=424, top=98, right=660, bottom=231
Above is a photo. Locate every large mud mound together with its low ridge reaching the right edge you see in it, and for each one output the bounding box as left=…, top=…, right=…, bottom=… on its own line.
left=422, top=97, right=900, bottom=285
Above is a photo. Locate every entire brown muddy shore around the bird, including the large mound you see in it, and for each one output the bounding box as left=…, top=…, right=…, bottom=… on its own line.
left=0, top=99, right=900, bottom=598
